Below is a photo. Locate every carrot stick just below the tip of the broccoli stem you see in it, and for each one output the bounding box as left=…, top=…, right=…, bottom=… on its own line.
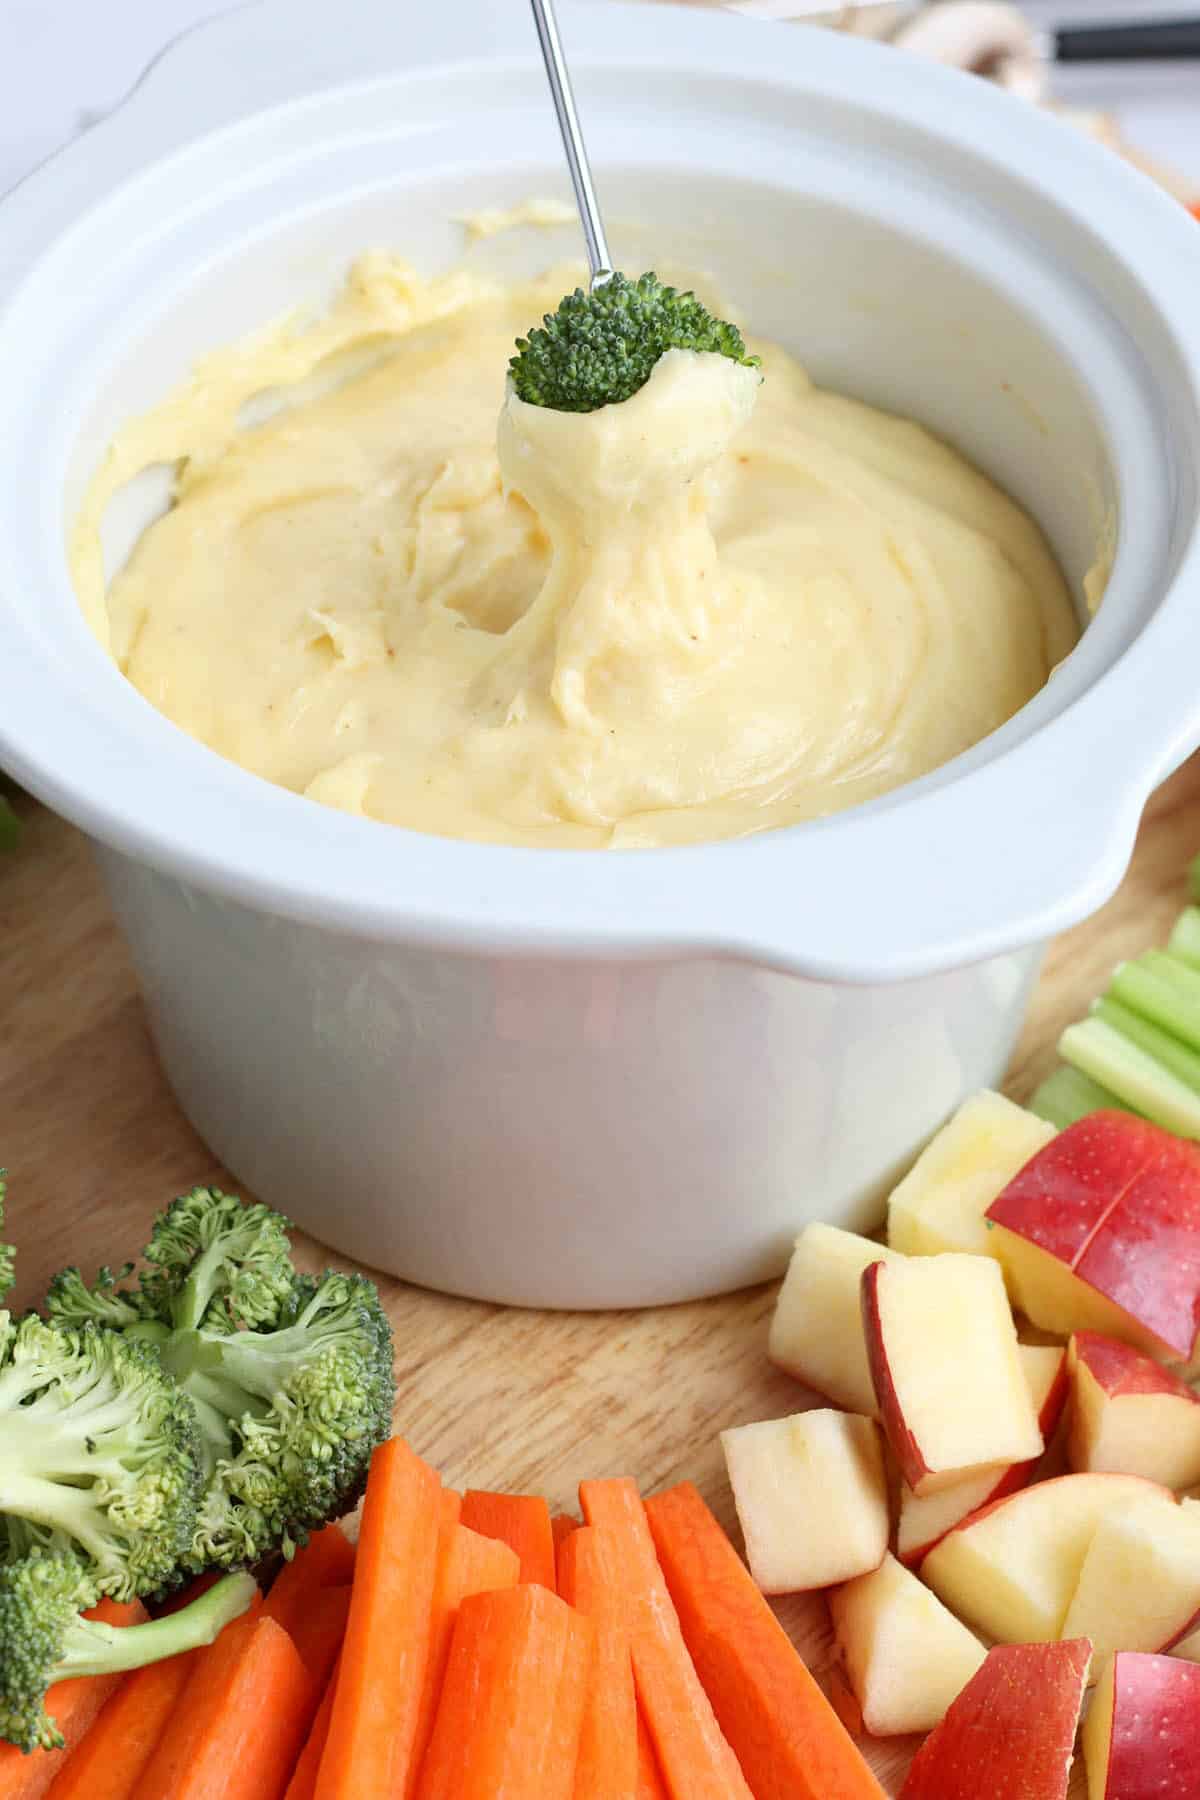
left=149, top=1616, right=317, bottom=1800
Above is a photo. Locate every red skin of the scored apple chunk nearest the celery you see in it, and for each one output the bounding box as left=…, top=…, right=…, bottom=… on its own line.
left=988, top=1112, right=1200, bottom=1361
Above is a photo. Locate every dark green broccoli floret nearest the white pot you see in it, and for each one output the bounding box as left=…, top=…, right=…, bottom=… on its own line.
left=47, top=1188, right=396, bottom=1570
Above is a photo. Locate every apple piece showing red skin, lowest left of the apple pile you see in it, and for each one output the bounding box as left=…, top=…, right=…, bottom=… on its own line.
left=900, top=1640, right=1090, bottom=1800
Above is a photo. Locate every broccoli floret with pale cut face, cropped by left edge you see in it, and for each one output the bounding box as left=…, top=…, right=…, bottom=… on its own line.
left=0, top=1314, right=203, bottom=1600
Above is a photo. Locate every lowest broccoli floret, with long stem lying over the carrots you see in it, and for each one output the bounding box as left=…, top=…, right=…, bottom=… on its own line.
left=0, top=1550, right=257, bottom=1751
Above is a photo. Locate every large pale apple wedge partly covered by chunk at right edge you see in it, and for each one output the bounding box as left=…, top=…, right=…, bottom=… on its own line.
left=921, top=1474, right=1171, bottom=1643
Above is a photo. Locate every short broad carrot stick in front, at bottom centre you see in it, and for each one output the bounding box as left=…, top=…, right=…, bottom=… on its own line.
left=417, top=1582, right=596, bottom=1800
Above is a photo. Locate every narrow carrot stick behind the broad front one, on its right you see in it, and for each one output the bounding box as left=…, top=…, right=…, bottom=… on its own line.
left=558, top=1525, right=637, bottom=1800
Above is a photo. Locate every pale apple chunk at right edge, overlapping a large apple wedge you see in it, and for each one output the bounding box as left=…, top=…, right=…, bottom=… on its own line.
left=1063, top=1492, right=1200, bottom=1674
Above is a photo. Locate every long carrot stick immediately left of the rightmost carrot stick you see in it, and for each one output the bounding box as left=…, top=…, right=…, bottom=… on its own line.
left=579, top=1480, right=752, bottom=1800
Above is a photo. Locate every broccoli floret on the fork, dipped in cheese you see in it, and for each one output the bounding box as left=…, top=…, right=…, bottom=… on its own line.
left=509, top=275, right=759, bottom=412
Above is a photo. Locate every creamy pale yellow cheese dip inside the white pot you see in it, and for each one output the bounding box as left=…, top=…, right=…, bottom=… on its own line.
left=72, top=256, right=1076, bottom=848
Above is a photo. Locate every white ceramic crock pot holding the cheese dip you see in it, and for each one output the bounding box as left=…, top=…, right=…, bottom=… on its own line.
left=0, top=0, right=1200, bottom=1307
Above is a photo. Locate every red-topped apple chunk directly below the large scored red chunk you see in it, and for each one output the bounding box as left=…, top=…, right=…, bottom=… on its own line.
left=1067, top=1332, right=1200, bottom=1489
